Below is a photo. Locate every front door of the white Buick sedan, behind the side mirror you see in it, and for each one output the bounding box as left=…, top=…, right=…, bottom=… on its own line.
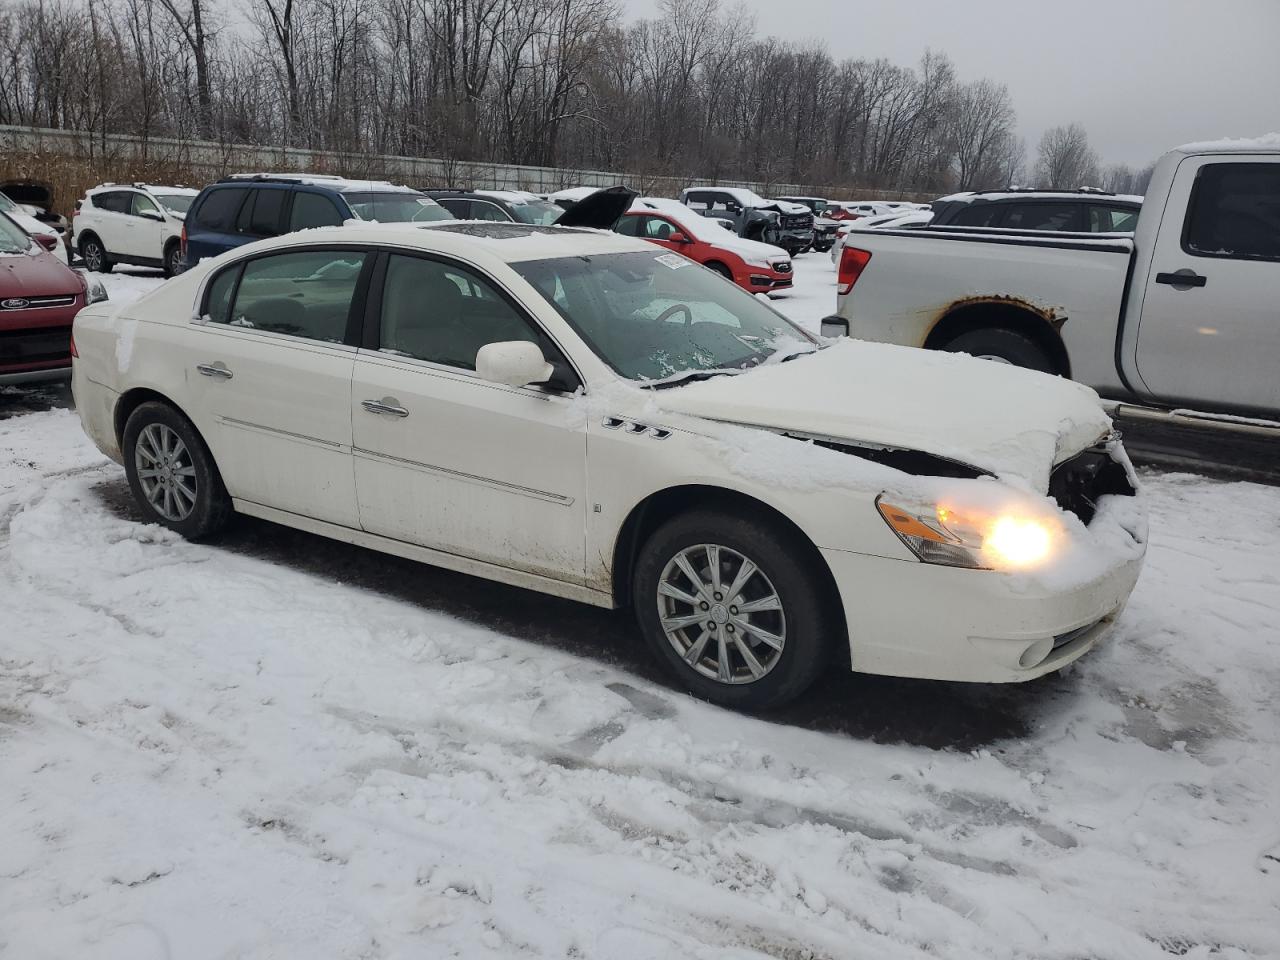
left=351, top=252, right=586, bottom=584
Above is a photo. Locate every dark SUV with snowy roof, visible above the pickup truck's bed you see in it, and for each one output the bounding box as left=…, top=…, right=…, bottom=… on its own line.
left=929, top=189, right=1142, bottom=233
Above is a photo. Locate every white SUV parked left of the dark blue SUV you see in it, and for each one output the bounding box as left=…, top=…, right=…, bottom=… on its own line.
left=72, top=183, right=200, bottom=276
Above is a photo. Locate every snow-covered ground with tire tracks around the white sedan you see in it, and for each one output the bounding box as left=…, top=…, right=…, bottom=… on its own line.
left=0, top=255, right=1280, bottom=960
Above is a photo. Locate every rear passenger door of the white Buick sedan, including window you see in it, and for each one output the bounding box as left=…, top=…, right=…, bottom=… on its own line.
left=176, top=246, right=372, bottom=529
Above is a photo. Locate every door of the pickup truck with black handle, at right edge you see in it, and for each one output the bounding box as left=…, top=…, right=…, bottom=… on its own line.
left=1137, top=156, right=1280, bottom=412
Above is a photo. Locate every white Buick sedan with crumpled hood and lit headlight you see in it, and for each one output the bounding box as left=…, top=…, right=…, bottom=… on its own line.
left=73, top=213, right=1146, bottom=708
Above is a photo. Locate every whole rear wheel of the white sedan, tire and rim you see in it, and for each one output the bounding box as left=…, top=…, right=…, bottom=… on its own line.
left=122, top=401, right=233, bottom=540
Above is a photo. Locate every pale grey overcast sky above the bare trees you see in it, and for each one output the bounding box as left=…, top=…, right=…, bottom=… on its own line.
left=622, top=0, right=1280, bottom=166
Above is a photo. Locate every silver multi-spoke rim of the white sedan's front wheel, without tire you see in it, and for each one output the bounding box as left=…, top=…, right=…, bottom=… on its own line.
left=657, top=544, right=787, bottom=684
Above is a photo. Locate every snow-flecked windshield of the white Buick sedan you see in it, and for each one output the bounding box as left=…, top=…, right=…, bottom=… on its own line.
left=512, top=252, right=817, bottom=380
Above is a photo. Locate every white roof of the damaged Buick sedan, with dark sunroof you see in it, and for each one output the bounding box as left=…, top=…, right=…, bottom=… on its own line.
left=206, top=220, right=660, bottom=264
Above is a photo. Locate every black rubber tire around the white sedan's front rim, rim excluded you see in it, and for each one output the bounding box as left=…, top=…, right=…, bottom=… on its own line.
left=632, top=509, right=840, bottom=710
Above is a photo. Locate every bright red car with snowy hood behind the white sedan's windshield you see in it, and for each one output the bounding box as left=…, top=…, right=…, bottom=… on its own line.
left=613, top=198, right=792, bottom=293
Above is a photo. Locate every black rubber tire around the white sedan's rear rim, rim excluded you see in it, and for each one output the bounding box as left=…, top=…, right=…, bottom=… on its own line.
left=122, top=401, right=233, bottom=540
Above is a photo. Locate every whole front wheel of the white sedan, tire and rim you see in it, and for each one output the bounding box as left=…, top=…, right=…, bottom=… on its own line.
left=632, top=509, right=838, bottom=709
